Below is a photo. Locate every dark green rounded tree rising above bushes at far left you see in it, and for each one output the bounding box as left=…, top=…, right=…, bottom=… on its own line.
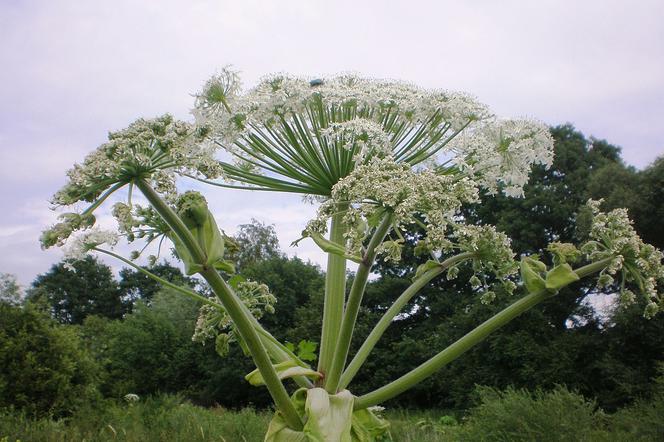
left=28, top=256, right=127, bottom=324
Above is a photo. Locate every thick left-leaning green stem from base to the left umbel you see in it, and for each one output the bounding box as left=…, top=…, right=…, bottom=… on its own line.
left=136, top=180, right=302, bottom=430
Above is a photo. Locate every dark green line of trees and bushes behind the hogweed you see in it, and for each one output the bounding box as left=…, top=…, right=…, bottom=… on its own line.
left=0, top=125, right=664, bottom=415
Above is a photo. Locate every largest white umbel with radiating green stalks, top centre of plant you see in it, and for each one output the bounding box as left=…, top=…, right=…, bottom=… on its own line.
left=193, top=71, right=553, bottom=196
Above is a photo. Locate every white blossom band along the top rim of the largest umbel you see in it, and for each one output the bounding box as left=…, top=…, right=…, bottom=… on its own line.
left=196, top=70, right=489, bottom=135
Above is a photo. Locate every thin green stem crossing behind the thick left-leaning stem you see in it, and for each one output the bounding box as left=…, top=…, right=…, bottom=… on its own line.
left=92, top=247, right=313, bottom=388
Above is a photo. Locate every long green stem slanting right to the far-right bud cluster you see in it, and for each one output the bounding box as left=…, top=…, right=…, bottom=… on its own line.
left=354, top=258, right=612, bottom=410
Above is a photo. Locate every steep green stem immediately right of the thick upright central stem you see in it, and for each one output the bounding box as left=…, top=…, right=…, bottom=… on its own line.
left=325, top=213, right=393, bottom=394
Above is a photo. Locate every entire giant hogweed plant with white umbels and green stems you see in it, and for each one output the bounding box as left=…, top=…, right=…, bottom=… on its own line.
left=41, top=69, right=664, bottom=441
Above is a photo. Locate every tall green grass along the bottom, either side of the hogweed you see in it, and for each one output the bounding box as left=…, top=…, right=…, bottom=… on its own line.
left=0, top=387, right=664, bottom=442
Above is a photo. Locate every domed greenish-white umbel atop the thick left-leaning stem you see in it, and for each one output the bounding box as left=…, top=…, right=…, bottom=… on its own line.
left=41, top=115, right=221, bottom=252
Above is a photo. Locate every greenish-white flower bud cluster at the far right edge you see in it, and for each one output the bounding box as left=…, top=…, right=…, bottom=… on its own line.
left=581, top=200, right=664, bottom=317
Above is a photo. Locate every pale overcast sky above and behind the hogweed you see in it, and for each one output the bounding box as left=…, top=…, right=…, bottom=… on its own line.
left=0, top=0, right=664, bottom=285
